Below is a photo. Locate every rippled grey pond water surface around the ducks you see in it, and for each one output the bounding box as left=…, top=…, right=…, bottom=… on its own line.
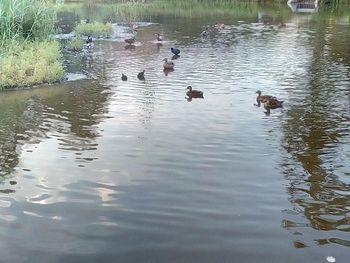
left=0, top=3, right=350, bottom=263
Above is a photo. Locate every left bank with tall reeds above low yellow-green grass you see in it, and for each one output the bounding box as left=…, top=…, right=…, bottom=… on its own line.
left=0, top=0, right=63, bottom=89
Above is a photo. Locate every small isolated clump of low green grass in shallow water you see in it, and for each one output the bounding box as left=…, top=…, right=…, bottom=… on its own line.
left=74, top=22, right=113, bottom=38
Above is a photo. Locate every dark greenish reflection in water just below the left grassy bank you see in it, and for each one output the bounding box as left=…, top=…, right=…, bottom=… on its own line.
left=0, top=82, right=109, bottom=180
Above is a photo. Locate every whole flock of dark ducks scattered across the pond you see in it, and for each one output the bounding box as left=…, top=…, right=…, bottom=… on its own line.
left=86, top=23, right=283, bottom=114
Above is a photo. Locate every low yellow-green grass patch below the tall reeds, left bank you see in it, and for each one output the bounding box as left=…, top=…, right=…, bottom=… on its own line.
left=0, top=41, right=64, bottom=89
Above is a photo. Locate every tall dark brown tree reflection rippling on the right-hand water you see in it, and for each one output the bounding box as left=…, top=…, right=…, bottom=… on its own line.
left=283, top=20, right=350, bottom=247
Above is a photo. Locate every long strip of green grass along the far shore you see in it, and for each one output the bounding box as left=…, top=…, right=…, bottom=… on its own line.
left=60, top=0, right=290, bottom=22
